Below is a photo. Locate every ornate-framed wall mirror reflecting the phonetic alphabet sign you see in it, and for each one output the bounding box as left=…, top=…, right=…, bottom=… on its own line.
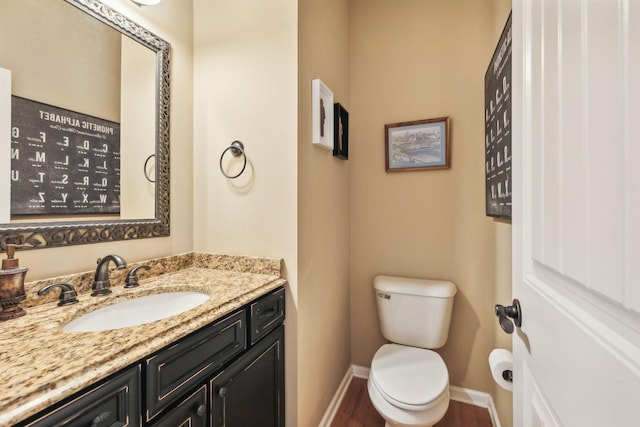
left=0, top=0, right=170, bottom=248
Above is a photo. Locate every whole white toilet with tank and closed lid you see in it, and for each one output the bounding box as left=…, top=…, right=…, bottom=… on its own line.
left=367, top=276, right=456, bottom=427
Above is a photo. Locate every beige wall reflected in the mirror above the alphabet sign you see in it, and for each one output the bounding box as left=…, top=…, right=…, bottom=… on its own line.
left=0, top=0, right=122, bottom=122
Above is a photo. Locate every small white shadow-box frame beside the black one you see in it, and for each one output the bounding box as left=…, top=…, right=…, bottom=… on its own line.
left=311, top=79, right=334, bottom=150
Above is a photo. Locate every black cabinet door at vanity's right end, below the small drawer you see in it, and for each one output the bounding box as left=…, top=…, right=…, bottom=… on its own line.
left=209, top=326, right=284, bottom=427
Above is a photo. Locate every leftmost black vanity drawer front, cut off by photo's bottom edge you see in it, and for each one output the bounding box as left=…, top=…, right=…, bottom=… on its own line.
left=23, top=365, right=141, bottom=427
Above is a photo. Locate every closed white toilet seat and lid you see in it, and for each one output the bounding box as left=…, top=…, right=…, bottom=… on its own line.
left=369, top=344, right=449, bottom=411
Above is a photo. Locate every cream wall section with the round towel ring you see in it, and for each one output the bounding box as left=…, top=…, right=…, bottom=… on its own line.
left=191, top=0, right=299, bottom=426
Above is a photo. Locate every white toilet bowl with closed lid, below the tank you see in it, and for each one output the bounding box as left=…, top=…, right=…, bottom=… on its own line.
left=367, top=344, right=449, bottom=427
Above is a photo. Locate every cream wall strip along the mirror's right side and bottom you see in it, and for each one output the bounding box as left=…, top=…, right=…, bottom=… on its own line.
left=18, top=0, right=193, bottom=280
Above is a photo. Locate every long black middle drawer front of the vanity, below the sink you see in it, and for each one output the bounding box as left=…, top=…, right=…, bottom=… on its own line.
left=144, top=310, right=247, bottom=421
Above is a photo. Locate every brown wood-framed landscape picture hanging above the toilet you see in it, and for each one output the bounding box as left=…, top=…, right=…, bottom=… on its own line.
left=384, top=117, right=451, bottom=172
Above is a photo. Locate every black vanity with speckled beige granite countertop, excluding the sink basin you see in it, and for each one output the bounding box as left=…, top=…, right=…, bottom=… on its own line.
left=0, top=256, right=286, bottom=427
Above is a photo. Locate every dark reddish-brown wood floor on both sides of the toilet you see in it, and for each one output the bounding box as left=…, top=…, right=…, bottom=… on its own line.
left=331, top=378, right=492, bottom=427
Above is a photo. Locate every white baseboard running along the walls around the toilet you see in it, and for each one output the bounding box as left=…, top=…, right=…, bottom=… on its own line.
left=318, top=365, right=501, bottom=427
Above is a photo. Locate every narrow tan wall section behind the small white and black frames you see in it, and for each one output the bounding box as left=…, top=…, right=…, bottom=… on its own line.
left=293, top=0, right=351, bottom=426
